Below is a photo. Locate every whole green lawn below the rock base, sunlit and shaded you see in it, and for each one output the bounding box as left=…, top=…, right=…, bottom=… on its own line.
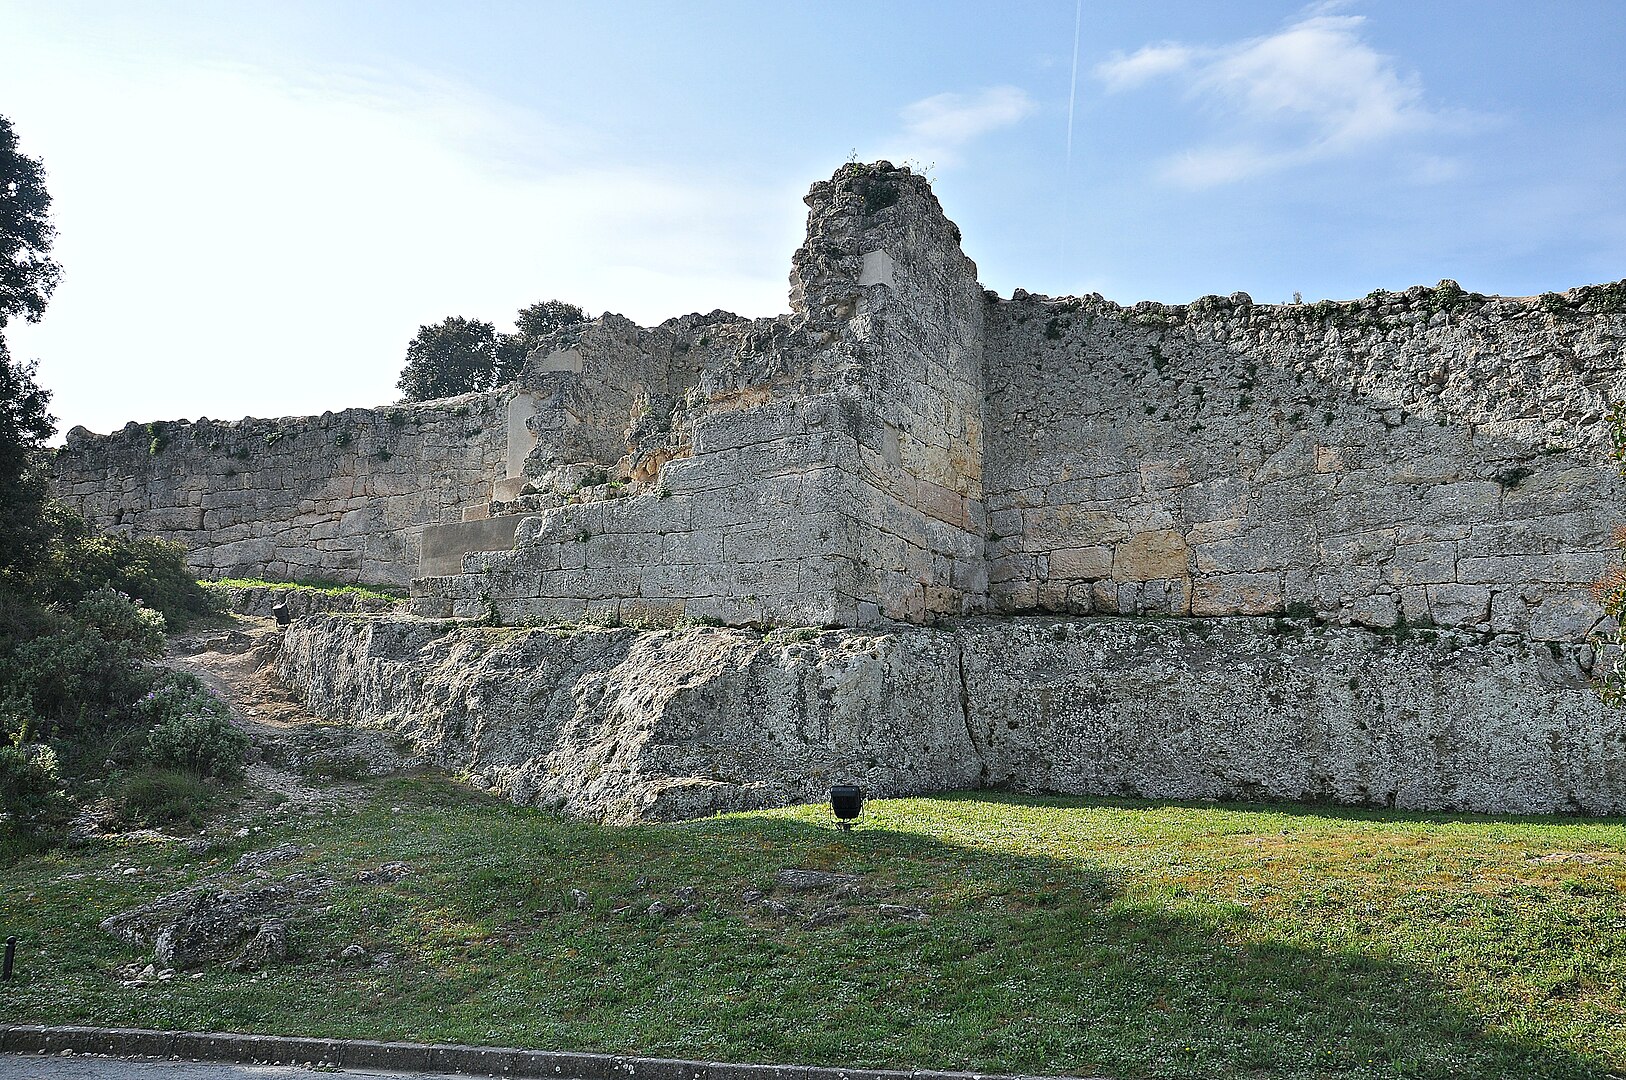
left=0, top=777, right=1626, bottom=1077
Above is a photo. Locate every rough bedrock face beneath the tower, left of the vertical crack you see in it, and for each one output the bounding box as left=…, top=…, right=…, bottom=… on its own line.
left=280, top=616, right=980, bottom=821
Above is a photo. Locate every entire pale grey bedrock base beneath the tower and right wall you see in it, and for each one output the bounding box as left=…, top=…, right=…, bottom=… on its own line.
left=280, top=615, right=1626, bottom=823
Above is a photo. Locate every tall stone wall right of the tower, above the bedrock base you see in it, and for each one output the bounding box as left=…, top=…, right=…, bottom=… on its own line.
left=985, top=283, right=1626, bottom=641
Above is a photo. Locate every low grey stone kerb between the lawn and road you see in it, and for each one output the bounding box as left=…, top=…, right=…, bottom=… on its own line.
left=0, top=1025, right=1105, bottom=1080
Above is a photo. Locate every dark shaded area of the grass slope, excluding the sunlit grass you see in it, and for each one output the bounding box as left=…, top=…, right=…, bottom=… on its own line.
left=15, top=781, right=1618, bottom=1080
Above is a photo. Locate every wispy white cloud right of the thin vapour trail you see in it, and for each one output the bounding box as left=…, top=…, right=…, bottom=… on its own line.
left=1096, top=3, right=1457, bottom=187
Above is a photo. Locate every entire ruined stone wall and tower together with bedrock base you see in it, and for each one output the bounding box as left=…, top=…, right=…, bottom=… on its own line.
left=55, top=163, right=1626, bottom=821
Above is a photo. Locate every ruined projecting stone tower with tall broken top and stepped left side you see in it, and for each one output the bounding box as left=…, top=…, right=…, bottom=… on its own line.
left=415, top=166, right=985, bottom=625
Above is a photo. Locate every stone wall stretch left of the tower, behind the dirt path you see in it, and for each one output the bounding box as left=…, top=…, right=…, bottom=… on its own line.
left=52, top=394, right=507, bottom=586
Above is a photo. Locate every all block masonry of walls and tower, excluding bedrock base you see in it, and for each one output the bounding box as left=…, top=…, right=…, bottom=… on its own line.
left=47, top=163, right=1626, bottom=642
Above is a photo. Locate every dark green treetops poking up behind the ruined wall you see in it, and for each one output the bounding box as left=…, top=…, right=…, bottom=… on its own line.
left=395, top=299, right=587, bottom=402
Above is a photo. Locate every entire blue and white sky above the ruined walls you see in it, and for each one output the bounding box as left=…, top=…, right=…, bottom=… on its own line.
left=0, top=0, right=1626, bottom=431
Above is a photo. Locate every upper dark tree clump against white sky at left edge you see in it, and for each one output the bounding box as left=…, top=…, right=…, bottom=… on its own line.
left=0, top=115, right=62, bottom=329
